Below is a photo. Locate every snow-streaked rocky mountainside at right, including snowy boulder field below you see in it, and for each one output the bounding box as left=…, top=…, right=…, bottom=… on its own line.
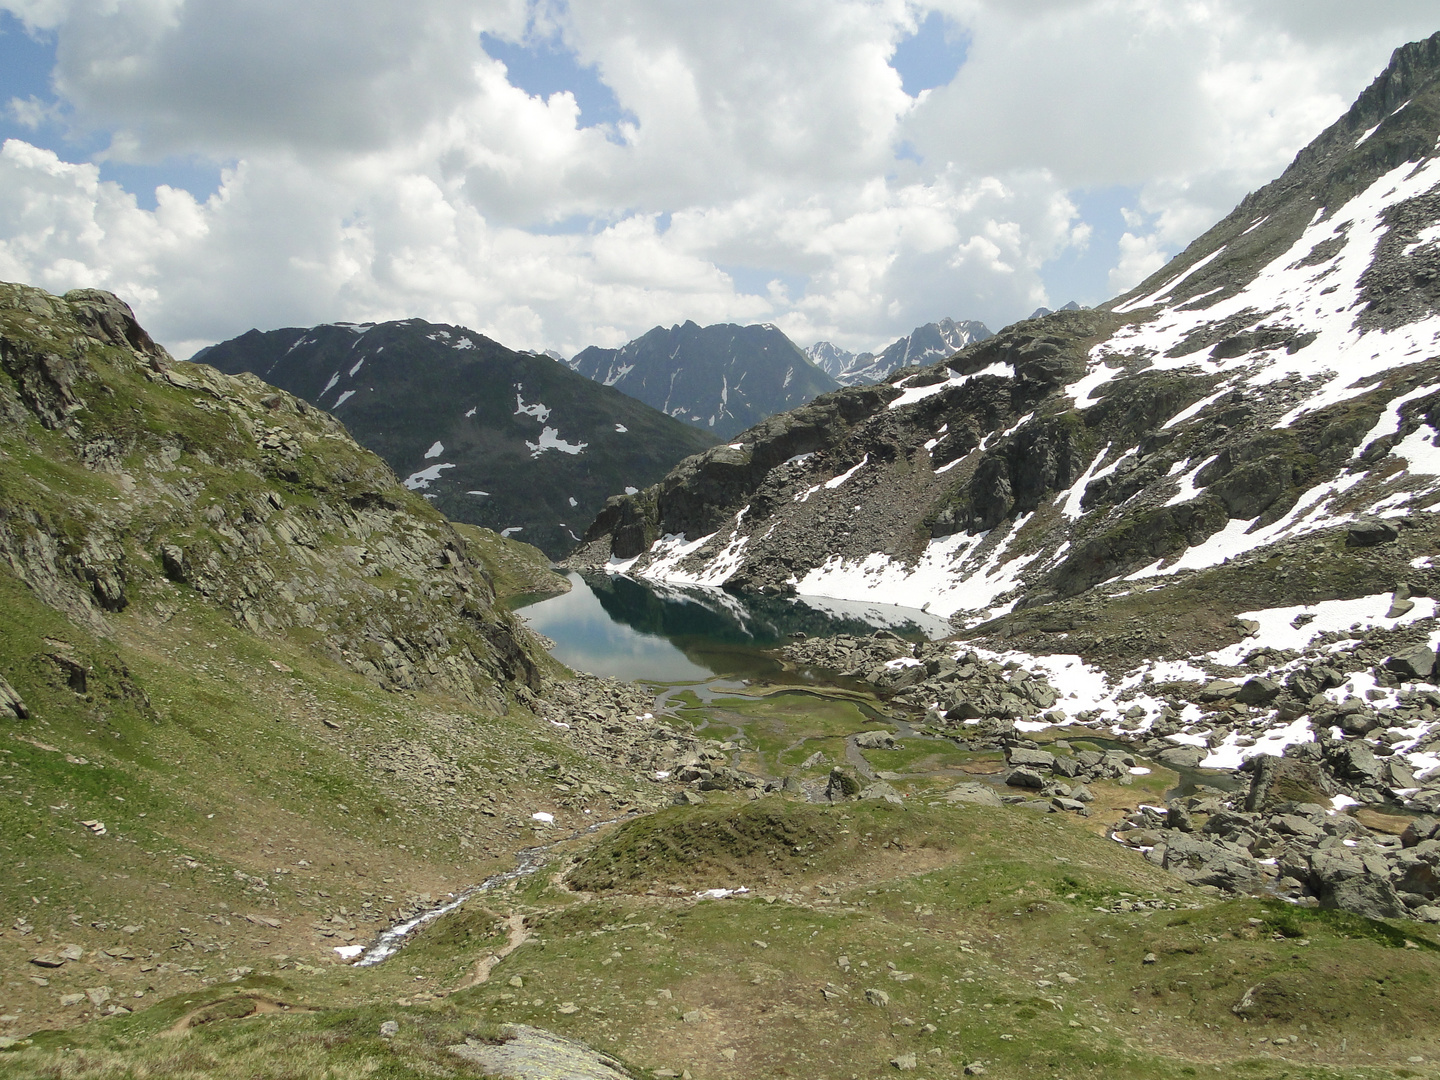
left=576, top=35, right=1440, bottom=805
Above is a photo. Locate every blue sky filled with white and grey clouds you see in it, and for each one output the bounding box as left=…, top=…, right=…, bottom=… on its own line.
left=0, top=0, right=1440, bottom=364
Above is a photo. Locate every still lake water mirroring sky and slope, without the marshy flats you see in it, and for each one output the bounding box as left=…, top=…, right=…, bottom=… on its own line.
left=520, top=573, right=949, bottom=683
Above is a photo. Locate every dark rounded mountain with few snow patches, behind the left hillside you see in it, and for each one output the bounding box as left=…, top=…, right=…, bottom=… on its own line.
left=194, top=320, right=713, bottom=557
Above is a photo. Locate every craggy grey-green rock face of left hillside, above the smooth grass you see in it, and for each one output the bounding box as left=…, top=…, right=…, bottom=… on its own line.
left=0, top=285, right=540, bottom=716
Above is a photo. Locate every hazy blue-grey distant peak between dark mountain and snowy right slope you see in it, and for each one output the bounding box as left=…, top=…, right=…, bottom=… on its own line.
left=570, top=321, right=838, bottom=439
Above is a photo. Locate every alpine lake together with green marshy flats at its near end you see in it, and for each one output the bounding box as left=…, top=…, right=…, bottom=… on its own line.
left=516, top=572, right=1215, bottom=809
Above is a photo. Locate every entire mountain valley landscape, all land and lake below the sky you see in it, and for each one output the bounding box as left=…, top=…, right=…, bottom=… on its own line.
left=0, top=27, right=1440, bottom=1080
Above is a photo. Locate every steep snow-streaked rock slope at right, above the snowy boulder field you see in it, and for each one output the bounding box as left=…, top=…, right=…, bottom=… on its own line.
left=576, top=37, right=1440, bottom=626
